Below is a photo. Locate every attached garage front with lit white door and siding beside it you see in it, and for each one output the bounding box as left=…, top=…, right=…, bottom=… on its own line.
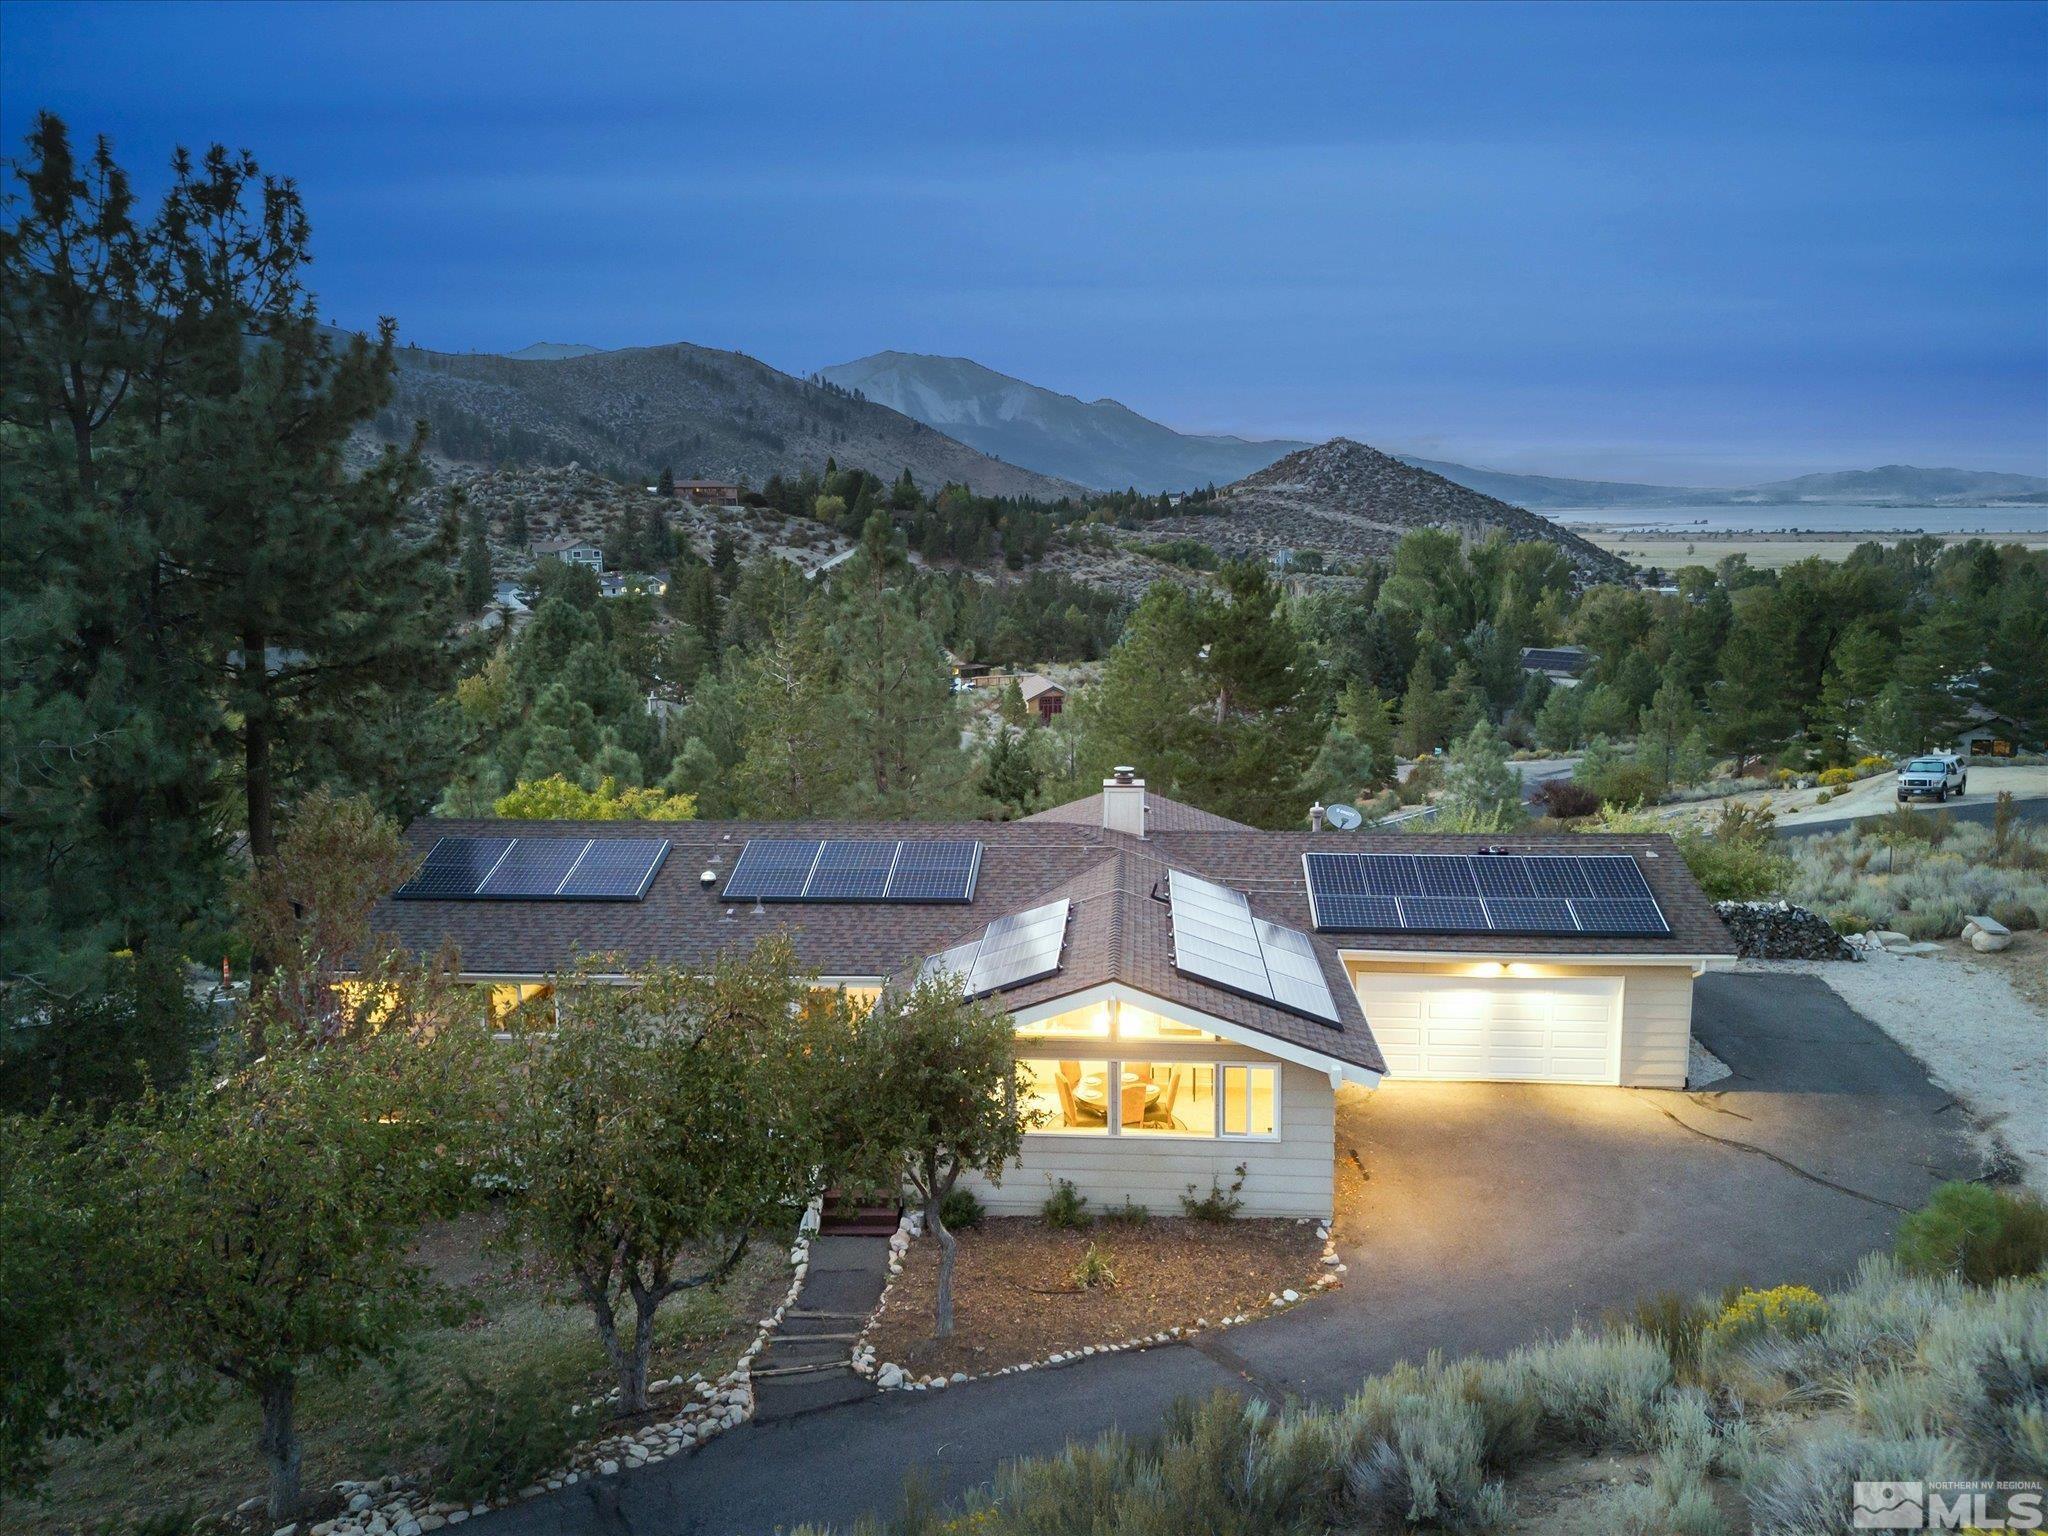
left=1346, top=954, right=1698, bottom=1087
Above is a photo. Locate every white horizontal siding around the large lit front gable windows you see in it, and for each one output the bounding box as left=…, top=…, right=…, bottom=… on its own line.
left=969, top=1040, right=1335, bottom=1219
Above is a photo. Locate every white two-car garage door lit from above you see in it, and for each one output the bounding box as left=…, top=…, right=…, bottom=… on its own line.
left=1358, top=971, right=1622, bottom=1083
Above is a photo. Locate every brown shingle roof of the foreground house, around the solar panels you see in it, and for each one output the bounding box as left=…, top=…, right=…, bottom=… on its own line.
left=375, top=795, right=1735, bottom=1071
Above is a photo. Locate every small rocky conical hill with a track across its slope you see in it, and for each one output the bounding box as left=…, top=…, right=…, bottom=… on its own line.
left=1147, top=438, right=1634, bottom=582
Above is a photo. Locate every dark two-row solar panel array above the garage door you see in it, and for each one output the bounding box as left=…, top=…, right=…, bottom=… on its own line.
left=1303, top=854, right=1671, bottom=938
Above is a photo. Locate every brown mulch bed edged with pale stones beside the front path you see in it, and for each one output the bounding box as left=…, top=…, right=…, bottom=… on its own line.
left=868, top=1217, right=1323, bottom=1376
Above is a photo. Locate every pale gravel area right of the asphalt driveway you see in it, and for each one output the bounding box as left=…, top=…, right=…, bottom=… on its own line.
left=1741, top=934, right=2048, bottom=1194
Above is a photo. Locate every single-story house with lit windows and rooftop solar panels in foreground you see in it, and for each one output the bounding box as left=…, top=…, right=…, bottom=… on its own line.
left=373, top=770, right=1735, bottom=1217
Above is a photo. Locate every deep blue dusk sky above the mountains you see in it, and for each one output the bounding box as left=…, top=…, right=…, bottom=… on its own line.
left=0, top=0, right=2048, bottom=483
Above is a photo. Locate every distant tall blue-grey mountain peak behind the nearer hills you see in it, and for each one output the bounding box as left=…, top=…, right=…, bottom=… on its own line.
left=819, top=352, right=1309, bottom=492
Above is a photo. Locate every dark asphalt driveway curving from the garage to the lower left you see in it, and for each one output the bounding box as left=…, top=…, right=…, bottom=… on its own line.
left=481, top=975, right=1974, bottom=1536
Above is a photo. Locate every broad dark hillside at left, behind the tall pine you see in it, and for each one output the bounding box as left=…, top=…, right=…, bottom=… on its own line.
left=377, top=342, right=1079, bottom=500
